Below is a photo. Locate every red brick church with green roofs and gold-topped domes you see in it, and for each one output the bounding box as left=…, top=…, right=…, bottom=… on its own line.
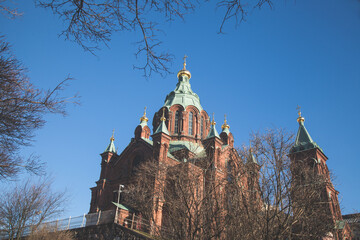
left=90, top=59, right=351, bottom=239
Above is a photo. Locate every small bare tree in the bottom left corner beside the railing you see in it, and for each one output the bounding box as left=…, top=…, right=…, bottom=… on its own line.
left=0, top=177, right=66, bottom=239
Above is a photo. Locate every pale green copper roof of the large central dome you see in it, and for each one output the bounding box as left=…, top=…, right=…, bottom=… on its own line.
left=164, top=75, right=203, bottom=111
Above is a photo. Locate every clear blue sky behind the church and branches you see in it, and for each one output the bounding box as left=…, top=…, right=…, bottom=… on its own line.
left=0, top=0, right=360, bottom=216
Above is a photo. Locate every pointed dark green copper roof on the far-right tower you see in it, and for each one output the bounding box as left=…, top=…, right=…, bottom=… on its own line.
left=290, top=121, right=322, bottom=153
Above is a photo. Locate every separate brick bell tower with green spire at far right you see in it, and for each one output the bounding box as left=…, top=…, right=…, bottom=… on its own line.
left=289, top=107, right=351, bottom=239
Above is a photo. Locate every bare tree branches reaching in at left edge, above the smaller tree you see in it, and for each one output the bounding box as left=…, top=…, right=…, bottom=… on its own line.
left=0, top=38, right=78, bottom=180
